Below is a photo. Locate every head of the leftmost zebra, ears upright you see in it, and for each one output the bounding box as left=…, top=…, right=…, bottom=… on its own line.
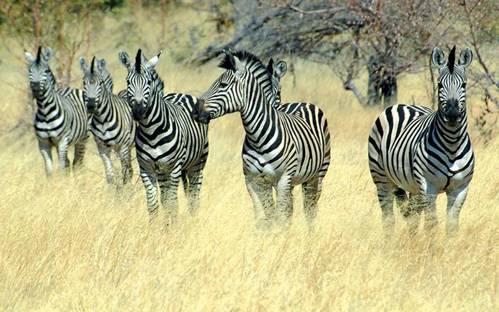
left=24, top=47, right=55, bottom=97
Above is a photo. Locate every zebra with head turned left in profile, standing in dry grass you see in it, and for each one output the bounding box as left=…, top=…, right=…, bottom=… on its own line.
left=193, top=50, right=331, bottom=229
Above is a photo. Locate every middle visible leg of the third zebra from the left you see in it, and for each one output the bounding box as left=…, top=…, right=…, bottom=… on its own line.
left=158, top=168, right=182, bottom=227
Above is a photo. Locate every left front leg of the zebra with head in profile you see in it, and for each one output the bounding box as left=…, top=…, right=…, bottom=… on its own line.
left=244, top=175, right=275, bottom=228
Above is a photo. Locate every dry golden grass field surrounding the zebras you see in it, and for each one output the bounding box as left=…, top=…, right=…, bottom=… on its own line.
left=0, top=4, right=499, bottom=311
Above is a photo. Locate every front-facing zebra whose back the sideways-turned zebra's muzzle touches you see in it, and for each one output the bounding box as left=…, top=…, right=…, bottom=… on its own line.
left=119, top=49, right=208, bottom=226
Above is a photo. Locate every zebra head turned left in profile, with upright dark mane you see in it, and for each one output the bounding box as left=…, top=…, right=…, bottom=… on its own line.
left=192, top=50, right=272, bottom=123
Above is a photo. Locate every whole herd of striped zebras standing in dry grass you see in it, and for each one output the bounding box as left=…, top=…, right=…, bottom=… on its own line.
left=25, top=47, right=474, bottom=235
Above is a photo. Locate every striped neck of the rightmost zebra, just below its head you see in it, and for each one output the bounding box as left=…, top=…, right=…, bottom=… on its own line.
left=430, top=112, right=469, bottom=156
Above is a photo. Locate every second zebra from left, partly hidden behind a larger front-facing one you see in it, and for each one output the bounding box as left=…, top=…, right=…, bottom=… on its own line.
left=80, top=57, right=135, bottom=185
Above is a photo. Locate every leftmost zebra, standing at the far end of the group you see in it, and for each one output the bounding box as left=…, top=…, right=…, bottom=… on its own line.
left=25, top=47, right=88, bottom=176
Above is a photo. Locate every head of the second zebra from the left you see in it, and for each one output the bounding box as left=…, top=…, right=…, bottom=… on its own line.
left=80, top=56, right=107, bottom=114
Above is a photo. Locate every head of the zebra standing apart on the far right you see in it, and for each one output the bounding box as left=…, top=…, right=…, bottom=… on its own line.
left=431, top=46, right=473, bottom=126
